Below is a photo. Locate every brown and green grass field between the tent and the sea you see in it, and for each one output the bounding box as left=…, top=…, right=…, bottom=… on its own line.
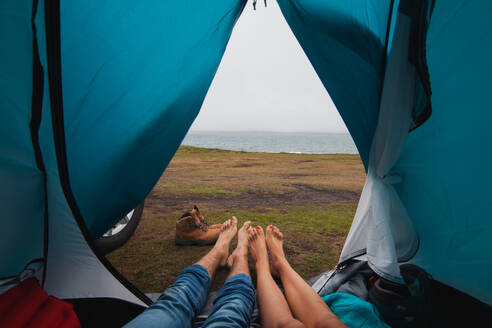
left=108, top=146, right=365, bottom=292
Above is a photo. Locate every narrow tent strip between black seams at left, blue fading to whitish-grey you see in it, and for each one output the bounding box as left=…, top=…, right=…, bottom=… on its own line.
left=35, top=1, right=147, bottom=305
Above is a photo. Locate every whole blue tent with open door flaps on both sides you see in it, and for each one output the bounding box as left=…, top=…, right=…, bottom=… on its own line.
left=0, top=0, right=492, bottom=326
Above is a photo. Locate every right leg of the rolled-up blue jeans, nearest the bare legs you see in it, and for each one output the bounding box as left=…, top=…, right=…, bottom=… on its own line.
left=203, top=273, right=256, bottom=328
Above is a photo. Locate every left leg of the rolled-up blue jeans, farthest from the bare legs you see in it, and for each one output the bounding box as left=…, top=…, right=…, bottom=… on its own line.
left=125, top=264, right=210, bottom=328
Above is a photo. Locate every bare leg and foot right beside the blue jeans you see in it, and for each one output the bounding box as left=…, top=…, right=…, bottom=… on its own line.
left=248, top=226, right=304, bottom=328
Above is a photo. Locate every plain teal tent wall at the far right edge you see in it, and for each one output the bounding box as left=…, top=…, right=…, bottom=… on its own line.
left=395, top=0, right=492, bottom=305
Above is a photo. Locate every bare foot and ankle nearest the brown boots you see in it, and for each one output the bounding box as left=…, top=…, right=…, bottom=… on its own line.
left=196, top=216, right=237, bottom=280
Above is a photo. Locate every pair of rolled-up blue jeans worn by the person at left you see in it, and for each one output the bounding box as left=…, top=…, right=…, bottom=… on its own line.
left=125, top=264, right=255, bottom=328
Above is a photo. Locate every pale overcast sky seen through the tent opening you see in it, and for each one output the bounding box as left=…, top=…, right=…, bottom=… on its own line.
left=191, top=0, right=347, bottom=133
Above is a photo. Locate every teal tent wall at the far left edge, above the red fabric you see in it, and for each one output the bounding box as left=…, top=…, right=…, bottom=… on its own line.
left=0, top=0, right=44, bottom=277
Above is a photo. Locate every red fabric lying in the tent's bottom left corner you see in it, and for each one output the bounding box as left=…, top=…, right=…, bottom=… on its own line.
left=0, top=278, right=80, bottom=328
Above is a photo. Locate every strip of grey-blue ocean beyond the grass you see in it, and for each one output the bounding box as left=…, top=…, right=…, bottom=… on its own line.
left=183, top=131, right=358, bottom=154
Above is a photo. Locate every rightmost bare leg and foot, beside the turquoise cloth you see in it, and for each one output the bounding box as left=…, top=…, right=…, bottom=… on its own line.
left=266, top=225, right=345, bottom=327
